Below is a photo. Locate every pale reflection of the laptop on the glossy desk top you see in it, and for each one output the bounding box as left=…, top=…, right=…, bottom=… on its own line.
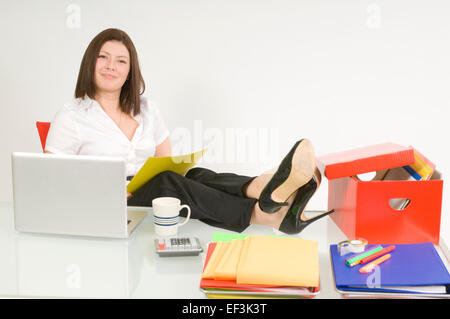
left=16, top=233, right=144, bottom=298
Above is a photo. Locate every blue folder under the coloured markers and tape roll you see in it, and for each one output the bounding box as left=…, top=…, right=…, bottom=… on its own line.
left=330, top=243, right=450, bottom=294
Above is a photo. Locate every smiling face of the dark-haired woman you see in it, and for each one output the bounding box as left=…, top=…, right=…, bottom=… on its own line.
left=94, top=41, right=130, bottom=92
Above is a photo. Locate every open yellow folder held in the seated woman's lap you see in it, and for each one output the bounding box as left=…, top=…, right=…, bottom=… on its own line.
left=127, top=148, right=206, bottom=193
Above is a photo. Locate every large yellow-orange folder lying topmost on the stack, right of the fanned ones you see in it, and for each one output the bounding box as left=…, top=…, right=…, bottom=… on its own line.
left=236, top=236, right=319, bottom=287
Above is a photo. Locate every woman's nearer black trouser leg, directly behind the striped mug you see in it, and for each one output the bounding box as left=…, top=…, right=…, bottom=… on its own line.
left=128, top=171, right=257, bottom=232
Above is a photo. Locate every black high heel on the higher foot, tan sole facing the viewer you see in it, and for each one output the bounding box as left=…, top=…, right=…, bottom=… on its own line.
left=258, top=139, right=315, bottom=214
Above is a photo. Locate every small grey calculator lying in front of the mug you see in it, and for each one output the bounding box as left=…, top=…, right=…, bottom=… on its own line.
left=155, top=237, right=203, bottom=257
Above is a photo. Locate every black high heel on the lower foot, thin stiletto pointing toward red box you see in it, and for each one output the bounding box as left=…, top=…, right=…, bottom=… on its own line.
left=278, top=173, right=334, bottom=234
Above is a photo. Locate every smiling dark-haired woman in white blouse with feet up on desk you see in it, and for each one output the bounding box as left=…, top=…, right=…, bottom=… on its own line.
left=46, top=29, right=330, bottom=234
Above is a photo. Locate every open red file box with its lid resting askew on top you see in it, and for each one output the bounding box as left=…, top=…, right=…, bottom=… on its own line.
left=316, top=143, right=443, bottom=244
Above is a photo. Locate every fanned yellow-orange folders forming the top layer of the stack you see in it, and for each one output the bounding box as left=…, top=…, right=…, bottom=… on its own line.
left=202, top=235, right=319, bottom=287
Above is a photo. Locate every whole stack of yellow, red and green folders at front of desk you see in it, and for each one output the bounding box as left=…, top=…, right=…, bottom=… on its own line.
left=200, top=233, right=319, bottom=298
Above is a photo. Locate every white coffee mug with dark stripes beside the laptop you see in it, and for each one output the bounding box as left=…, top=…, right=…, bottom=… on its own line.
left=152, top=197, right=191, bottom=236
